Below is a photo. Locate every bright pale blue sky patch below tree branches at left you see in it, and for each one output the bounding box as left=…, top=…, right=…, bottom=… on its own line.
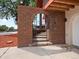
left=0, top=18, right=17, bottom=29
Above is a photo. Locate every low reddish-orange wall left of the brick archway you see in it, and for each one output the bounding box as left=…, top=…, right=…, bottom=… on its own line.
left=0, top=34, right=18, bottom=48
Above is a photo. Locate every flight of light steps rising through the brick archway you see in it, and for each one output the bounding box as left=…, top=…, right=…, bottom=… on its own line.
left=32, top=32, right=52, bottom=46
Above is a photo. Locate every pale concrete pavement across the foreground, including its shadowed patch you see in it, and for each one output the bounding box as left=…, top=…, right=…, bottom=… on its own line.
left=0, top=46, right=79, bottom=59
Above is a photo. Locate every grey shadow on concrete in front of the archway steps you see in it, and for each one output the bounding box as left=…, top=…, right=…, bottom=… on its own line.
left=20, top=47, right=69, bottom=56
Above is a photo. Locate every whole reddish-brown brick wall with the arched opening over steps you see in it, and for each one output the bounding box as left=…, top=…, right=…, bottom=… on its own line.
left=18, top=5, right=65, bottom=47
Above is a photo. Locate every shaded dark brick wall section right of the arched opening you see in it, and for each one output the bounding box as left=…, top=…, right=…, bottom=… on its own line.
left=46, top=10, right=65, bottom=44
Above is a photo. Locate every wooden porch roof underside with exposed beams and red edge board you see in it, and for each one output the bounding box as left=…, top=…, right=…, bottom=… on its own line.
left=43, top=0, right=79, bottom=11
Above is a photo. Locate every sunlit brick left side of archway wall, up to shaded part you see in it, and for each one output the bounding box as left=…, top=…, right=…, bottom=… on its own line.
left=18, top=5, right=43, bottom=47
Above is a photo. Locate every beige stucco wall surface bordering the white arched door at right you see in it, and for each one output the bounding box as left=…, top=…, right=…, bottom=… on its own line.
left=65, top=6, right=79, bottom=44
